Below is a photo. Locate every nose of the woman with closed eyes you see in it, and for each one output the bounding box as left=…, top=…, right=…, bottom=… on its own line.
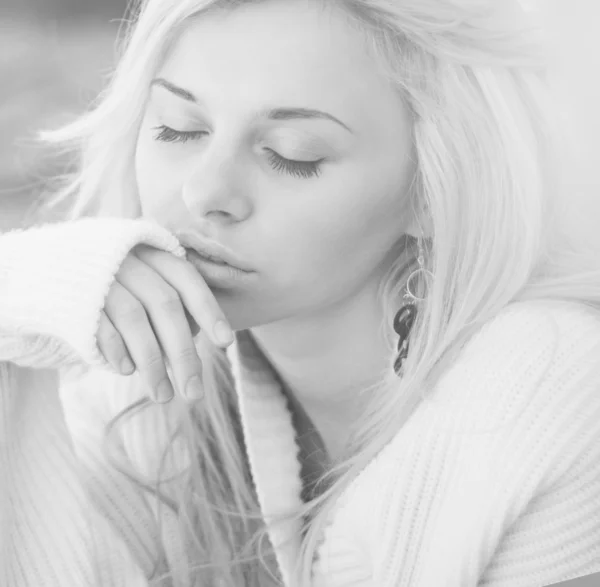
left=182, top=149, right=252, bottom=224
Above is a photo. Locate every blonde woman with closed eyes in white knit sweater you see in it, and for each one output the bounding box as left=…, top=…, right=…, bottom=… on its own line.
left=0, top=0, right=600, bottom=587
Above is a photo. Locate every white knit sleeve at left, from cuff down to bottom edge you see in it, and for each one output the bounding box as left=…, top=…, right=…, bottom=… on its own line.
left=0, top=218, right=185, bottom=587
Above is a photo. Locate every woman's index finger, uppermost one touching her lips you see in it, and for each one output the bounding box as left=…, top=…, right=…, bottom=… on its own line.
left=135, top=246, right=233, bottom=347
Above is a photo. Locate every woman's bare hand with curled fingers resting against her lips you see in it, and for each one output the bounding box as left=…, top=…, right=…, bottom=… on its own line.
left=97, top=245, right=233, bottom=403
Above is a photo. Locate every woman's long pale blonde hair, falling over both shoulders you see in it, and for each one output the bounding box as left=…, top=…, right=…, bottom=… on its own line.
left=35, top=0, right=600, bottom=587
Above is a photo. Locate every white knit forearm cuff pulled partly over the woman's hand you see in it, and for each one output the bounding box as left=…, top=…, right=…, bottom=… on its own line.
left=0, top=218, right=185, bottom=366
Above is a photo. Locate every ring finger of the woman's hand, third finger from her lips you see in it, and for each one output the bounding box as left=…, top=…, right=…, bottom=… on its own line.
left=104, top=280, right=174, bottom=403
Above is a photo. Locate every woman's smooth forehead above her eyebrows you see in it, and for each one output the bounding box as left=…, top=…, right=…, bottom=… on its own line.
left=160, top=0, right=406, bottom=132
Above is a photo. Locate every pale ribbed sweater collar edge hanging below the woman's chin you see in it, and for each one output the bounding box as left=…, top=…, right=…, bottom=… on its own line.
left=227, top=330, right=303, bottom=585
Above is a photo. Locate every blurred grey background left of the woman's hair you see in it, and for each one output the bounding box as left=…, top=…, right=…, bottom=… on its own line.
left=0, top=0, right=127, bottom=231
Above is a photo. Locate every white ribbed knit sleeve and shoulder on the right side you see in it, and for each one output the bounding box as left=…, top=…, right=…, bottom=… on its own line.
left=370, top=300, right=600, bottom=587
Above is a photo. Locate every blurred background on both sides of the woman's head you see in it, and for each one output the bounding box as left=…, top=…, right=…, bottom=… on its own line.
left=0, top=0, right=600, bottom=241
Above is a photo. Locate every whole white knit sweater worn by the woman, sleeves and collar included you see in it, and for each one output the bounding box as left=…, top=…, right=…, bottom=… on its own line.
left=0, top=218, right=600, bottom=587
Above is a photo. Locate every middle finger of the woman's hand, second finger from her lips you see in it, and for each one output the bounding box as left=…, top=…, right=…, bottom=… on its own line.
left=117, top=256, right=202, bottom=399
